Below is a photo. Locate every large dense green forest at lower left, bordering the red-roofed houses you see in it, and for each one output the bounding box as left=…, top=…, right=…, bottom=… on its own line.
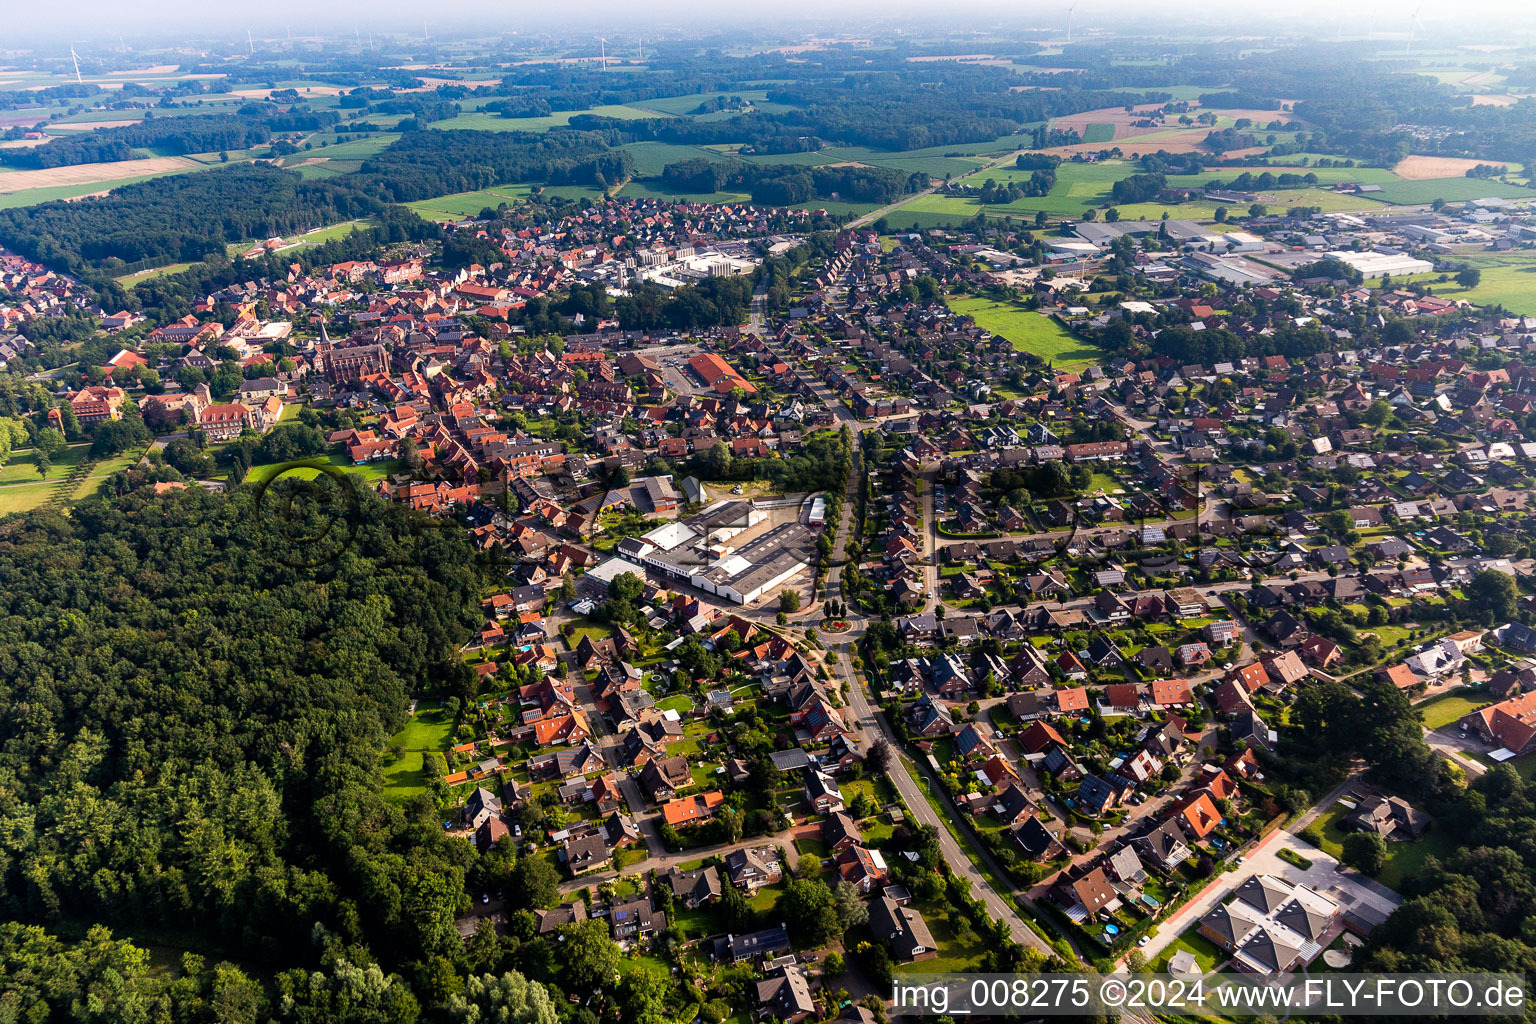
left=0, top=488, right=478, bottom=1000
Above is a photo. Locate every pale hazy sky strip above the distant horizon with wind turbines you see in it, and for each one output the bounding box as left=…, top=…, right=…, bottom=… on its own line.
left=9, top=0, right=1536, bottom=49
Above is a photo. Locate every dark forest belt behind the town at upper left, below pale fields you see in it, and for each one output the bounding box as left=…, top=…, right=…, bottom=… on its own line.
left=0, top=164, right=381, bottom=276
